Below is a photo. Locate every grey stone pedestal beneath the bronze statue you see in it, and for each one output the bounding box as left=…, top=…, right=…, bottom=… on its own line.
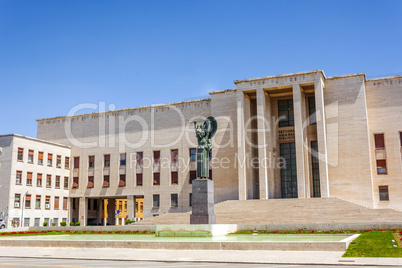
left=190, top=179, right=216, bottom=224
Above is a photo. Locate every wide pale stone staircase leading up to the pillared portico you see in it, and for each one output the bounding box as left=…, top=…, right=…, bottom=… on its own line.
left=136, top=197, right=402, bottom=225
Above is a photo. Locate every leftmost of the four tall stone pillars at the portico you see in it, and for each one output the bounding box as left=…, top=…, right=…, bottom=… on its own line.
left=235, top=90, right=247, bottom=200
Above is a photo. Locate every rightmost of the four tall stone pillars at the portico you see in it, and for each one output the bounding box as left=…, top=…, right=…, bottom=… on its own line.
left=314, top=75, right=329, bottom=197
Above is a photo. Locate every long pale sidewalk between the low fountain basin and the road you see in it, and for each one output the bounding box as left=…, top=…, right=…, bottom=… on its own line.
left=0, top=247, right=402, bottom=267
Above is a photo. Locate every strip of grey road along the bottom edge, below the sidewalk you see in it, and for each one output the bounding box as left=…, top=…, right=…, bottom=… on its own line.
left=0, top=257, right=392, bottom=268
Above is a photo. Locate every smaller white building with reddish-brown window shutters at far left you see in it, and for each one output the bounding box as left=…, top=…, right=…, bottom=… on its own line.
left=0, top=134, right=71, bottom=228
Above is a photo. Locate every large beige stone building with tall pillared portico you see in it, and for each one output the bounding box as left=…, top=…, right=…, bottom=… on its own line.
left=37, top=70, right=402, bottom=223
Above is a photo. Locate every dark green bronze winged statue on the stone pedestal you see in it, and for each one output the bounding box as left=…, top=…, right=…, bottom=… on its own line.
left=194, top=116, right=218, bottom=179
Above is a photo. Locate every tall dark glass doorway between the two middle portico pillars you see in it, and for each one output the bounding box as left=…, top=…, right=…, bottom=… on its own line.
left=280, top=142, right=297, bottom=198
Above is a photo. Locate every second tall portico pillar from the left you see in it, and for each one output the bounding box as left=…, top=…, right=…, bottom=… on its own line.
left=257, top=88, right=268, bottom=199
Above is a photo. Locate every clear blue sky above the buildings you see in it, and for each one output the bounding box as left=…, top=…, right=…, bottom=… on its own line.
left=0, top=0, right=402, bottom=137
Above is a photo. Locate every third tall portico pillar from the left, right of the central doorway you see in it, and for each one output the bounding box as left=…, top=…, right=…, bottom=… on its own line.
left=293, top=84, right=306, bottom=198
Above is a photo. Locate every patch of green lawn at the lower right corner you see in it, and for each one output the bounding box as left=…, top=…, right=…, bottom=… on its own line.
left=343, top=231, right=402, bottom=257
